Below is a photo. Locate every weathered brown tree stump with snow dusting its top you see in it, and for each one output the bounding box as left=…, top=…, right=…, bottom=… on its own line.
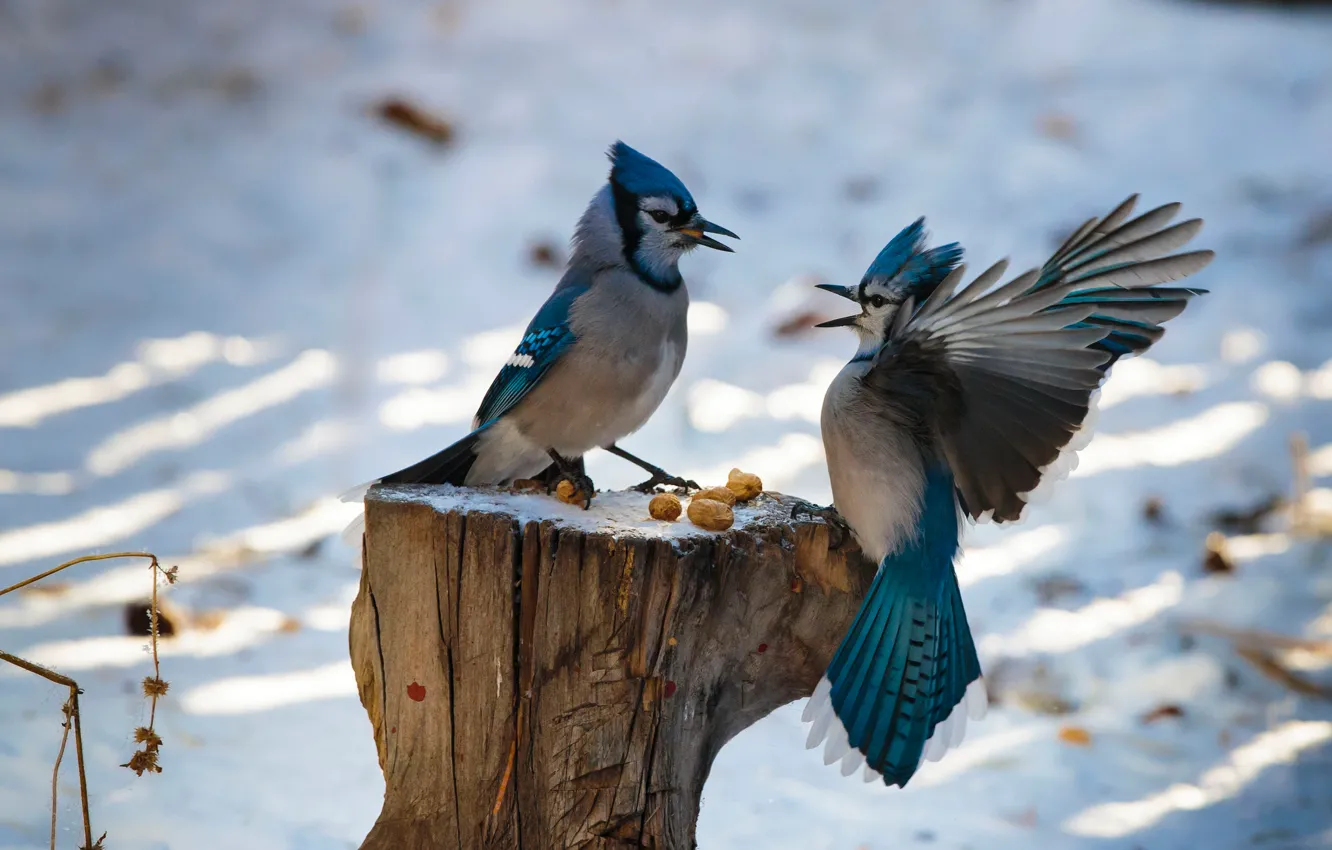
left=350, top=486, right=874, bottom=850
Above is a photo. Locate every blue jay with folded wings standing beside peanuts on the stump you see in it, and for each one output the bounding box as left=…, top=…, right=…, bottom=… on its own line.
left=344, top=141, right=739, bottom=506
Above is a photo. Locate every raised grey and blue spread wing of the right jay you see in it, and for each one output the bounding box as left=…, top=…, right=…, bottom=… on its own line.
left=863, top=199, right=1212, bottom=521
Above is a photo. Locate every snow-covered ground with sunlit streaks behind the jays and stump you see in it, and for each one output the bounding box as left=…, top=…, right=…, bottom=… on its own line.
left=0, top=0, right=1332, bottom=850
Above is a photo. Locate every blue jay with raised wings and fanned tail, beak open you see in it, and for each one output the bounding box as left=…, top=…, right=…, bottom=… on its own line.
left=797, top=196, right=1212, bottom=786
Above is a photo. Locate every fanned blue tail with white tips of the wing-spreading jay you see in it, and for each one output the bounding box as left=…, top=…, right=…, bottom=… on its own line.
left=810, top=470, right=983, bottom=786
